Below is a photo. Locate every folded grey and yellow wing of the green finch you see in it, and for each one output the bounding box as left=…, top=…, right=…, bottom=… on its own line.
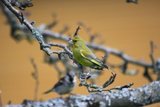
left=80, top=50, right=101, bottom=66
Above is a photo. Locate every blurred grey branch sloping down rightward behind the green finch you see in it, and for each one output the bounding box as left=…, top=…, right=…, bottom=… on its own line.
left=42, top=30, right=152, bottom=68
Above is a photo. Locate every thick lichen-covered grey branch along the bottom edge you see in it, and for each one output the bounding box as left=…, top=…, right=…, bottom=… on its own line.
left=8, top=81, right=160, bottom=107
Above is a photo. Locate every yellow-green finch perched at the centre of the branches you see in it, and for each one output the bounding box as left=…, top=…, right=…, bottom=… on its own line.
left=72, top=26, right=108, bottom=70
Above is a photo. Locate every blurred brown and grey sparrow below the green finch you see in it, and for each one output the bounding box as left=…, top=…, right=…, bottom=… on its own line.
left=44, top=71, right=76, bottom=95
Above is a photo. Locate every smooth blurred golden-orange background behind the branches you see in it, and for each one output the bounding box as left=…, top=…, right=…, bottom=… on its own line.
left=0, top=0, right=160, bottom=107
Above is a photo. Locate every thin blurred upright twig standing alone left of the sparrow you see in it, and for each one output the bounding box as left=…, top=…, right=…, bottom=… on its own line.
left=31, top=58, right=39, bottom=101
